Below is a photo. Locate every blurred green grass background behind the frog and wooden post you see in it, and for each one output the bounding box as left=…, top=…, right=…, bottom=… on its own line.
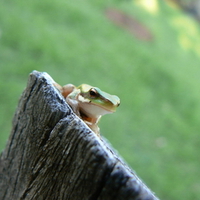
left=0, top=0, right=200, bottom=200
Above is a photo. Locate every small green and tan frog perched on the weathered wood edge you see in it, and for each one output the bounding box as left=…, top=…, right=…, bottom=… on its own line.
left=53, top=84, right=120, bottom=137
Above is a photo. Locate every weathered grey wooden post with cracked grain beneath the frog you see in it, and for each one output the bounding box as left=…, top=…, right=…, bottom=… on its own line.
left=0, top=71, right=157, bottom=200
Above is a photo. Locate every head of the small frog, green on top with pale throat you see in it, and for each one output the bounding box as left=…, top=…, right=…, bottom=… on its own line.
left=77, top=84, right=120, bottom=117
